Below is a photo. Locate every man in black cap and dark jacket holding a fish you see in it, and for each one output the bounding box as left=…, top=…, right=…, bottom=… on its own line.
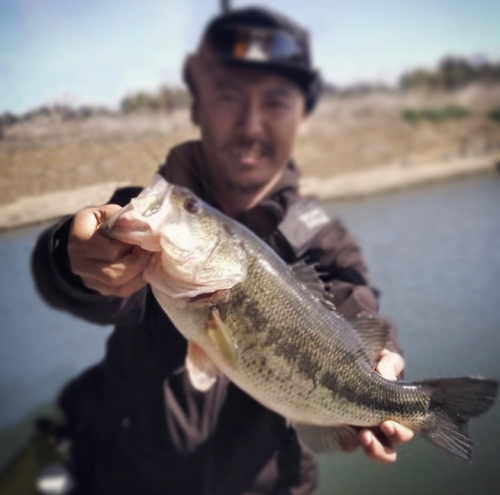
left=33, top=4, right=413, bottom=495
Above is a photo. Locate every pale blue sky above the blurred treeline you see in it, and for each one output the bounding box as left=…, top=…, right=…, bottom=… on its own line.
left=0, top=0, right=500, bottom=114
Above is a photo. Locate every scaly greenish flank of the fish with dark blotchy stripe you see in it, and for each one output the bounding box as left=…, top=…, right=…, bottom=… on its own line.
left=215, top=231, right=428, bottom=426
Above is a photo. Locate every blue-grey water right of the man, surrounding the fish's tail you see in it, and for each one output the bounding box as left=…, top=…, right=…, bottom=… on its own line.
left=320, top=175, right=500, bottom=495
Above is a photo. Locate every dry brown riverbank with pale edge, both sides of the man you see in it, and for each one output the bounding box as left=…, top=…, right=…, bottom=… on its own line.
left=0, top=85, right=500, bottom=230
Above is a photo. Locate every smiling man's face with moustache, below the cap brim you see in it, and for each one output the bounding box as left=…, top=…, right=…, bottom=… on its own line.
left=196, top=59, right=305, bottom=193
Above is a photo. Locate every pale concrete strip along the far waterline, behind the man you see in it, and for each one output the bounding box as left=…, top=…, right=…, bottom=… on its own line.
left=0, top=152, right=500, bottom=230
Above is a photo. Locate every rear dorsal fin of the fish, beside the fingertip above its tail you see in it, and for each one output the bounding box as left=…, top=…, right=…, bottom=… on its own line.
left=346, top=313, right=389, bottom=368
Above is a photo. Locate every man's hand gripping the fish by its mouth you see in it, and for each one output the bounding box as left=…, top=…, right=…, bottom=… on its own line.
left=68, top=205, right=151, bottom=297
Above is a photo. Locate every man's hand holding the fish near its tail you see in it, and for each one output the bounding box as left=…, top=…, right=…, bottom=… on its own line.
left=359, top=349, right=415, bottom=464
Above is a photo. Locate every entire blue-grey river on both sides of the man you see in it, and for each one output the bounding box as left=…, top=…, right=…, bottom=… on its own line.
left=0, top=174, right=500, bottom=495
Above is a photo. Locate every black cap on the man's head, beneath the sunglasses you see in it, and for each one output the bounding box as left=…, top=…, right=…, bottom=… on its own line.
left=199, top=7, right=322, bottom=113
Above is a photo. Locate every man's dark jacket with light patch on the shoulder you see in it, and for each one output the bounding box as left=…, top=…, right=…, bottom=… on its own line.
left=32, top=142, right=399, bottom=495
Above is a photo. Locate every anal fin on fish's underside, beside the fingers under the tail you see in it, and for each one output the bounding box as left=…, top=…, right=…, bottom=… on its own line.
left=293, top=423, right=359, bottom=454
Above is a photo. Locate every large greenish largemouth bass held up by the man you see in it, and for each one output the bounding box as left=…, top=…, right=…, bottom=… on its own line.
left=100, top=175, right=498, bottom=459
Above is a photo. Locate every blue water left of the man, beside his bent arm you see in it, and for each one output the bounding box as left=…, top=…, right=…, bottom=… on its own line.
left=0, top=222, right=110, bottom=469
